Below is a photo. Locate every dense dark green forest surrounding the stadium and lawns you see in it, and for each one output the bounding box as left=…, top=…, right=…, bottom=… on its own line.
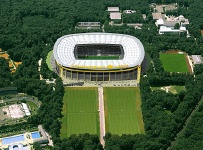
left=0, top=0, right=203, bottom=150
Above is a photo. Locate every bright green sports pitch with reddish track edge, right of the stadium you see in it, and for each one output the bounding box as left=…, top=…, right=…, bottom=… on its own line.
left=160, top=54, right=189, bottom=72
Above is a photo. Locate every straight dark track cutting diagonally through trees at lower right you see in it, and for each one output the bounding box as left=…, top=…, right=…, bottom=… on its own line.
left=167, top=97, right=203, bottom=150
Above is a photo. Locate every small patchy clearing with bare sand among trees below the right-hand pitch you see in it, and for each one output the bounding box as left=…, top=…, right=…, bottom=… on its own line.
left=151, top=86, right=186, bottom=94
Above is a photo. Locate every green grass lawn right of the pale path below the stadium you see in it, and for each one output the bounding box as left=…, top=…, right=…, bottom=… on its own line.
left=104, top=87, right=145, bottom=135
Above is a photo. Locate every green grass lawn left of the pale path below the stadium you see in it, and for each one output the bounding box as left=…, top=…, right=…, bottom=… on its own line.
left=61, top=87, right=99, bottom=138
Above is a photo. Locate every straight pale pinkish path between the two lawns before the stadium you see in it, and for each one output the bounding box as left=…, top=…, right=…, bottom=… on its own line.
left=98, top=86, right=106, bottom=147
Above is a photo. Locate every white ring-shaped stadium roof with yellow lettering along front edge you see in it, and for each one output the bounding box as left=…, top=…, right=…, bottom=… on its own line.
left=53, top=33, right=145, bottom=70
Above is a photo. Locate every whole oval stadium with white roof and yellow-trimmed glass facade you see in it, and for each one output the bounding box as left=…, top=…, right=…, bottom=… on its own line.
left=53, top=33, right=145, bottom=81
